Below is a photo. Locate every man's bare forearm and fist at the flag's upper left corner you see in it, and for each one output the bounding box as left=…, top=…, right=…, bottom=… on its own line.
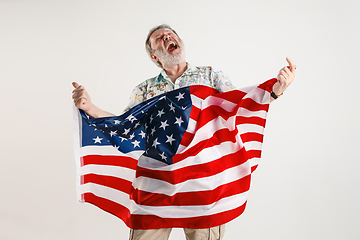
left=72, top=82, right=115, bottom=118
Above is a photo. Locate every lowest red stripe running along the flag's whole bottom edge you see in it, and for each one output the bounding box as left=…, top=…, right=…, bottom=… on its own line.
left=84, top=193, right=246, bottom=229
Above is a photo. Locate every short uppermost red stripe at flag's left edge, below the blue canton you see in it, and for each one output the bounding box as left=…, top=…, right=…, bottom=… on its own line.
left=83, top=155, right=137, bottom=170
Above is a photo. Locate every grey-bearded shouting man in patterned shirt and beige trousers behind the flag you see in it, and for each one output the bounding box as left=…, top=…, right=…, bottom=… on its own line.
left=73, top=24, right=296, bottom=240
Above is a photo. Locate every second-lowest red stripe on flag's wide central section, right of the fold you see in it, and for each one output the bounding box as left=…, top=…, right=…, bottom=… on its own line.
left=130, top=175, right=251, bottom=206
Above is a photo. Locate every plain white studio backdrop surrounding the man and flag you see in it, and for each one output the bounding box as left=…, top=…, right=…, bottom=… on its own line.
left=0, top=0, right=360, bottom=240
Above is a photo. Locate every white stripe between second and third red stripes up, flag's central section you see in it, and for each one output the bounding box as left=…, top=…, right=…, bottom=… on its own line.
left=133, top=159, right=251, bottom=196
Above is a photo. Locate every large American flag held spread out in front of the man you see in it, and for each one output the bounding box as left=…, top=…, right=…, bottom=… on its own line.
left=74, top=79, right=276, bottom=229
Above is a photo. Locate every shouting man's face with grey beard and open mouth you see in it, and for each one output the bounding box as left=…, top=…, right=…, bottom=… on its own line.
left=150, top=28, right=185, bottom=68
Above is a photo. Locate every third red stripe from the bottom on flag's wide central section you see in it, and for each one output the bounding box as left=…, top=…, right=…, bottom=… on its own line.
left=136, top=148, right=248, bottom=184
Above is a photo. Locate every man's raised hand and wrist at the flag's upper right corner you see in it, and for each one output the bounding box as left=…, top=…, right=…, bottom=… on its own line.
left=270, top=57, right=296, bottom=102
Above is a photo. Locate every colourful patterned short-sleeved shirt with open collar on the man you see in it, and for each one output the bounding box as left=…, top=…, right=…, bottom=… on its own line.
left=125, top=64, right=235, bottom=111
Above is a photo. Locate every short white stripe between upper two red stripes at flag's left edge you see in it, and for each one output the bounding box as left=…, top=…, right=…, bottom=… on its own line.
left=80, top=164, right=136, bottom=182
